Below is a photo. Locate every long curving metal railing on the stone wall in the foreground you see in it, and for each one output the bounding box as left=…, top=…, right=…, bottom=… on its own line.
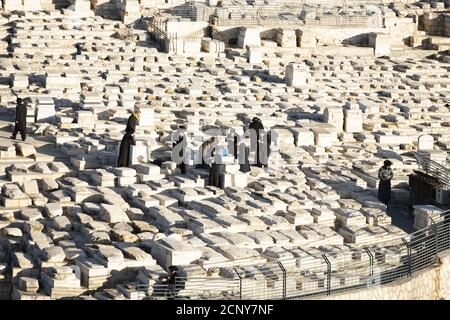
left=139, top=211, right=450, bottom=300
